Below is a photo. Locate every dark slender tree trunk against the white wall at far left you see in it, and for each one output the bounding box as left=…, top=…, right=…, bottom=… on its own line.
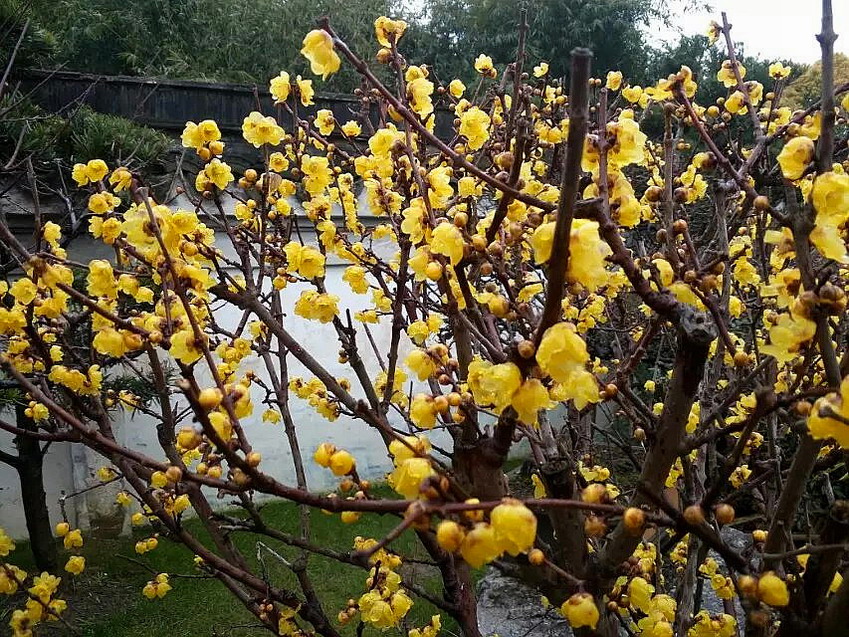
left=15, top=405, right=59, bottom=573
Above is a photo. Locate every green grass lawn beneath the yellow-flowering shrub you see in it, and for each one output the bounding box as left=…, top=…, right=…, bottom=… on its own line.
left=0, top=487, right=464, bottom=637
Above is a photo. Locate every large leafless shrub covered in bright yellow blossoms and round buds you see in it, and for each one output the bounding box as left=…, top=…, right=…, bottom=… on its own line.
left=0, top=2, right=849, bottom=636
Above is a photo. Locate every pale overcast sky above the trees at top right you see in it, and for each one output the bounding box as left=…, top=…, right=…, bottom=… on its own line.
left=660, top=0, right=849, bottom=62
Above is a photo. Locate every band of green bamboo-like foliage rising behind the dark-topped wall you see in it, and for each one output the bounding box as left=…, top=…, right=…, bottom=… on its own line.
left=21, top=0, right=692, bottom=92
